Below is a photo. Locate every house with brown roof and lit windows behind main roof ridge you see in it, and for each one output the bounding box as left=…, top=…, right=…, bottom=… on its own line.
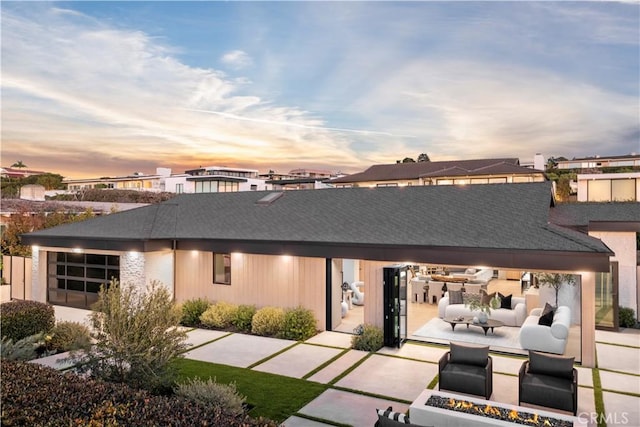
left=328, top=158, right=547, bottom=187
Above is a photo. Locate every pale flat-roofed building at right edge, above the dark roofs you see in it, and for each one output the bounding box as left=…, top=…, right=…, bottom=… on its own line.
left=577, top=172, right=640, bottom=202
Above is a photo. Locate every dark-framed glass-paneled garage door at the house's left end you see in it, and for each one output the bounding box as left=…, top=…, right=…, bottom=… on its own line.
left=47, top=252, right=120, bottom=308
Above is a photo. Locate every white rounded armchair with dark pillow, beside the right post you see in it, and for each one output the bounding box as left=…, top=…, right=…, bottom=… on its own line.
left=519, top=305, right=571, bottom=354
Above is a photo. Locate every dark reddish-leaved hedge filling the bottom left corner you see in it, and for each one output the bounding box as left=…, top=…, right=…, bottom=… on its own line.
left=0, top=361, right=276, bottom=427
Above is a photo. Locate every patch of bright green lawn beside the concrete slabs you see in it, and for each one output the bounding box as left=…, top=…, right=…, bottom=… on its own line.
left=178, top=359, right=329, bottom=423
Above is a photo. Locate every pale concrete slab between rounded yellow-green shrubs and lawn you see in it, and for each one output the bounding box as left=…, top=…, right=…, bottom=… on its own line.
left=185, top=334, right=296, bottom=368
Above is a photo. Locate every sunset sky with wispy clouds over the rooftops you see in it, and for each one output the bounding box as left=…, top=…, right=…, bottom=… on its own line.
left=0, top=1, right=640, bottom=178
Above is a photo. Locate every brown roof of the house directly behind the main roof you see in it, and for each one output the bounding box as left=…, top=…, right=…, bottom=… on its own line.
left=329, top=158, right=542, bottom=184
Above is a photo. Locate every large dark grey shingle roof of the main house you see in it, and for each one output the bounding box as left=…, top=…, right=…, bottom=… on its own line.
left=23, top=182, right=611, bottom=268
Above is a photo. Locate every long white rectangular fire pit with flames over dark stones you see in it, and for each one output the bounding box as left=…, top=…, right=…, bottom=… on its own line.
left=409, top=390, right=587, bottom=427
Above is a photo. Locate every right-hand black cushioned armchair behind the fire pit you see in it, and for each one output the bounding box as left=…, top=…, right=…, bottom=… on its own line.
left=518, top=351, right=578, bottom=415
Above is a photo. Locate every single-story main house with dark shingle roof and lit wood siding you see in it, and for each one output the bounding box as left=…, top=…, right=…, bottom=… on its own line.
left=22, top=182, right=614, bottom=366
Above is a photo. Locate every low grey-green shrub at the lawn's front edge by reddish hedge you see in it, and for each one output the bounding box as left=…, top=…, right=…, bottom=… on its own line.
left=175, top=378, right=246, bottom=415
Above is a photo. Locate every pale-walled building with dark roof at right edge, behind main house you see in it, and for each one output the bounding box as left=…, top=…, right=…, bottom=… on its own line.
left=550, top=202, right=640, bottom=329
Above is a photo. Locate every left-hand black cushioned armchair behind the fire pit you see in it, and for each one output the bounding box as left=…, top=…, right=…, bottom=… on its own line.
left=438, top=342, right=493, bottom=399
